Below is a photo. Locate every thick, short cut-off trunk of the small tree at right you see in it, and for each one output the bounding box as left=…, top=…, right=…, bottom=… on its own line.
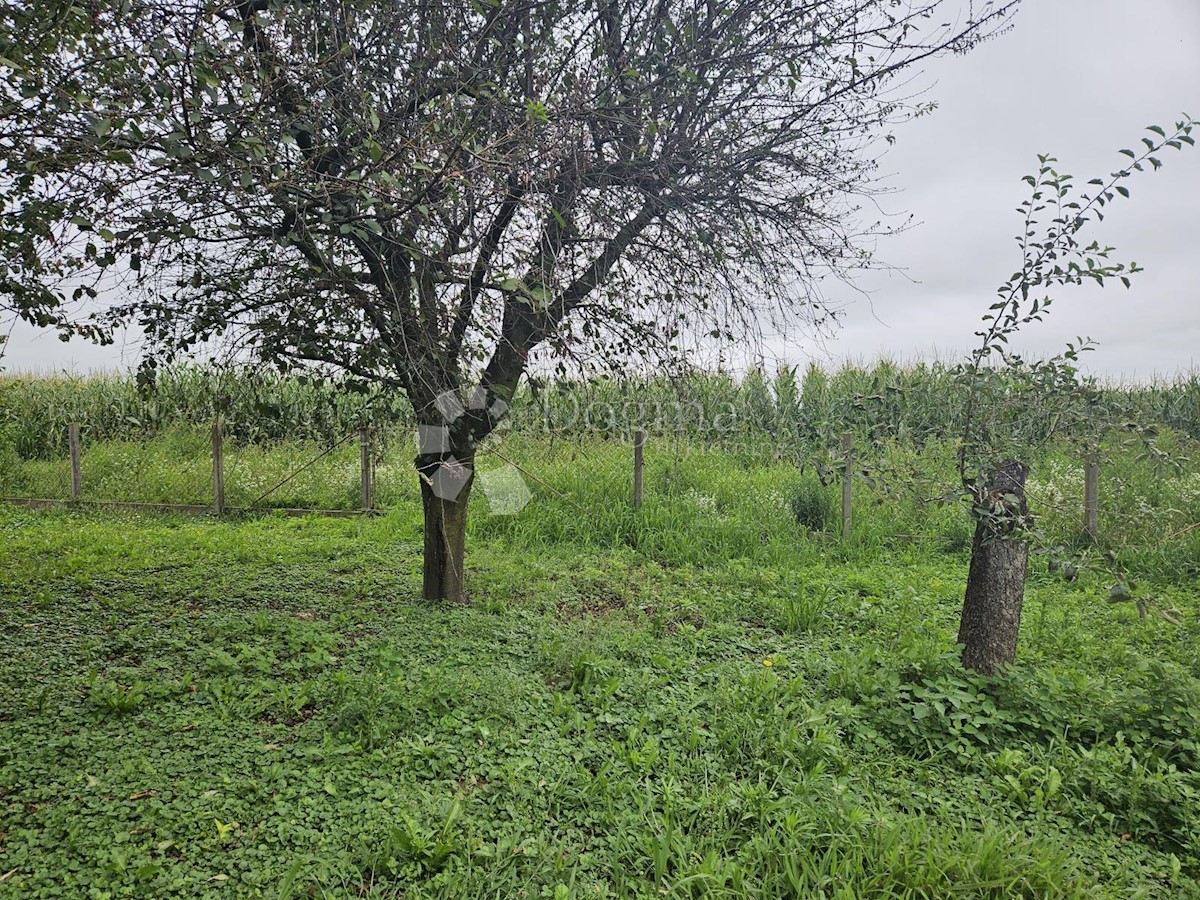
left=959, top=460, right=1030, bottom=674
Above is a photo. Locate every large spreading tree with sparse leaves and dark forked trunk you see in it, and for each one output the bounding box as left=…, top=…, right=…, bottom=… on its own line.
left=0, top=0, right=1016, bottom=601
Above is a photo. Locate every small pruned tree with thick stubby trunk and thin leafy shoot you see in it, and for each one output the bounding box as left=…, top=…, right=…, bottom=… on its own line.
left=959, top=118, right=1198, bottom=674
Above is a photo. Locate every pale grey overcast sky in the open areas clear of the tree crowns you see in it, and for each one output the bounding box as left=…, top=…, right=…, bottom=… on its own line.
left=4, top=0, right=1200, bottom=378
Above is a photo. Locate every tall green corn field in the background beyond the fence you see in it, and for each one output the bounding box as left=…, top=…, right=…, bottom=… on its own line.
left=0, top=362, right=1200, bottom=460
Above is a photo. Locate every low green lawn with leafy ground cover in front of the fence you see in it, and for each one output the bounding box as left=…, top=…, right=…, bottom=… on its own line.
left=0, top=497, right=1200, bottom=900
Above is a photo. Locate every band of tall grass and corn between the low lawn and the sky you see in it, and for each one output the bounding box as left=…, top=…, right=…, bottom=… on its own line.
left=0, top=364, right=1200, bottom=577
